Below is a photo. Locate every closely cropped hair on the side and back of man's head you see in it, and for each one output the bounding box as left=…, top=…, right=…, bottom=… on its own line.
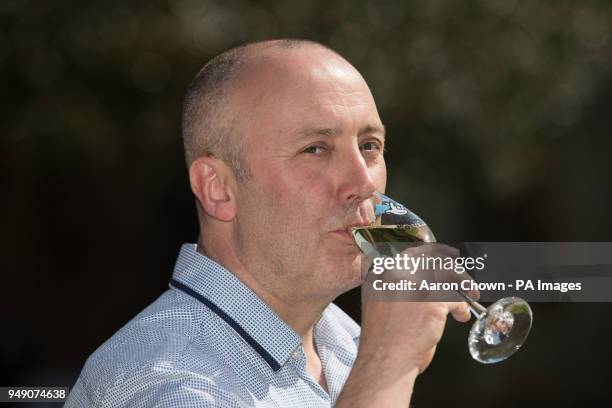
left=182, top=39, right=342, bottom=181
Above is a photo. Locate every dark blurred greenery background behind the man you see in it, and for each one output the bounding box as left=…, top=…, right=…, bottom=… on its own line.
left=0, top=0, right=612, bottom=407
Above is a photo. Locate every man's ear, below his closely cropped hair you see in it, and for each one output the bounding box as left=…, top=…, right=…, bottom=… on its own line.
left=189, top=156, right=236, bottom=221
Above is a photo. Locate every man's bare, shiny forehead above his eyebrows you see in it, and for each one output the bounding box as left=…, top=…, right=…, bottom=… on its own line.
left=235, top=47, right=381, bottom=142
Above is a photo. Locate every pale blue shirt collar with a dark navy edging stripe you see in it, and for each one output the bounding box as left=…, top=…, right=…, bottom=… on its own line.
left=170, top=244, right=301, bottom=371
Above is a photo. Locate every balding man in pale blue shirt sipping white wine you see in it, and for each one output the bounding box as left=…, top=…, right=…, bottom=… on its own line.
left=66, top=40, right=469, bottom=407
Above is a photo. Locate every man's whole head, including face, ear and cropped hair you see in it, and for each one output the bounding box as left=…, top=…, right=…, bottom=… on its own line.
left=184, top=40, right=386, bottom=310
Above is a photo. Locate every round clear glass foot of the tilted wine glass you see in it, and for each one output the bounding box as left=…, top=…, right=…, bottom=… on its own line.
left=468, top=297, right=533, bottom=364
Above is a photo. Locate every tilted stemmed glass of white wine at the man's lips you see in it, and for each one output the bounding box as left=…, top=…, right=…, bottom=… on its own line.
left=351, top=193, right=533, bottom=364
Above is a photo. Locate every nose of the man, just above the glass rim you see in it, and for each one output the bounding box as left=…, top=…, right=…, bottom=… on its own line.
left=339, top=146, right=376, bottom=203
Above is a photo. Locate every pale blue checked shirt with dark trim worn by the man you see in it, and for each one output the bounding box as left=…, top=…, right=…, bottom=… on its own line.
left=65, top=244, right=359, bottom=408
